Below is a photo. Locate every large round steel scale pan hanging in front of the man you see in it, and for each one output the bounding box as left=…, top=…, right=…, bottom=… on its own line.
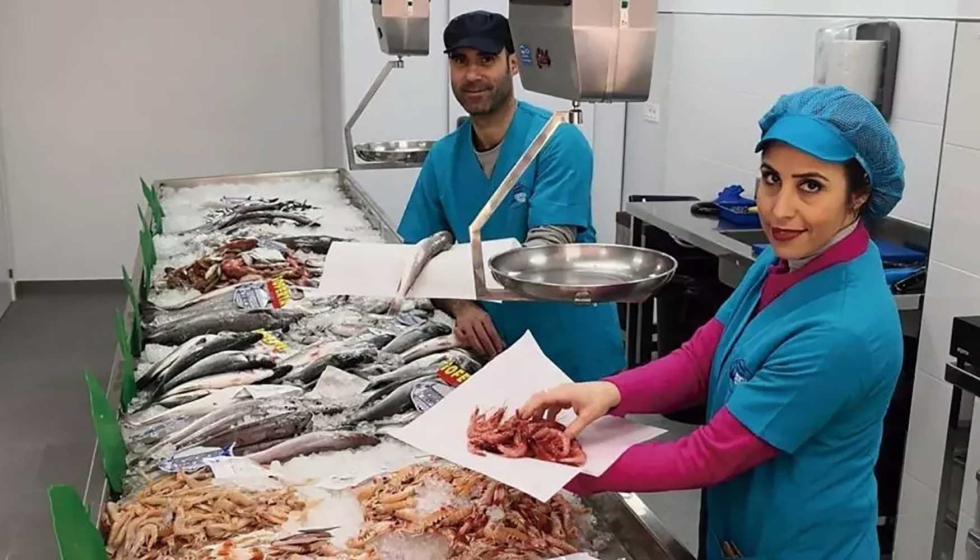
left=489, top=243, right=677, bottom=303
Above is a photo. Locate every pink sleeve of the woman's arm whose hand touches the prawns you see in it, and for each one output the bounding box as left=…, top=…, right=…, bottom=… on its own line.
left=604, top=319, right=725, bottom=416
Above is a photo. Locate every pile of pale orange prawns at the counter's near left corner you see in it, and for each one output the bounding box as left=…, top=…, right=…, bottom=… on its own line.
left=101, top=473, right=306, bottom=560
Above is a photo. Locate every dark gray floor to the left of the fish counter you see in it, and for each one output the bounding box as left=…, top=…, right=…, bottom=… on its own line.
left=0, top=284, right=125, bottom=560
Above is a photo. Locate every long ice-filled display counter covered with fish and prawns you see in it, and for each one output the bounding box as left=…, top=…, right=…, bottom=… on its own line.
left=84, top=170, right=691, bottom=560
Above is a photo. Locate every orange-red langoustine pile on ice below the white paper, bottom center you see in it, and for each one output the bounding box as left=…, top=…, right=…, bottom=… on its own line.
left=346, top=463, right=588, bottom=560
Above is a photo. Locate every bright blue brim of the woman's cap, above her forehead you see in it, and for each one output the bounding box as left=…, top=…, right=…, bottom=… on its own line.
left=755, top=115, right=858, bottom=163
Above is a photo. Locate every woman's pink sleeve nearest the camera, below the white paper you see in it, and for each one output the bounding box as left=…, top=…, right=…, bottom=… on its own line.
left=566, top=408, right=779, bottom=496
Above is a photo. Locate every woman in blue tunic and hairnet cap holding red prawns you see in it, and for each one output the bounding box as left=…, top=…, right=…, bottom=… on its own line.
left=522, top=88, right=904, bottom=560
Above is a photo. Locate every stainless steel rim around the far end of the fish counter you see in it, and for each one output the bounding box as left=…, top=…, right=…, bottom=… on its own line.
left=153, top=169, right=402, bottom=243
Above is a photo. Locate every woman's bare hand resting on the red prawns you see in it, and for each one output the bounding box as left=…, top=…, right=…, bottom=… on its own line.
left=521, top=381, right=622, bottom=437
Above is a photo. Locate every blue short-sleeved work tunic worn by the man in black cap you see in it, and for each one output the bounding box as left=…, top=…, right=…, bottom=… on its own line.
left=398, top=102, right=625, bottom=381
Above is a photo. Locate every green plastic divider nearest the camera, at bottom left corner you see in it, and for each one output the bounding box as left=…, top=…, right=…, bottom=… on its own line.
left=48, top=485, right=109, bottom=560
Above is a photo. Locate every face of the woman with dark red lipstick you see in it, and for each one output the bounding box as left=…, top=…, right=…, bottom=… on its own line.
left=755, top=142, right=867, bottom=259
